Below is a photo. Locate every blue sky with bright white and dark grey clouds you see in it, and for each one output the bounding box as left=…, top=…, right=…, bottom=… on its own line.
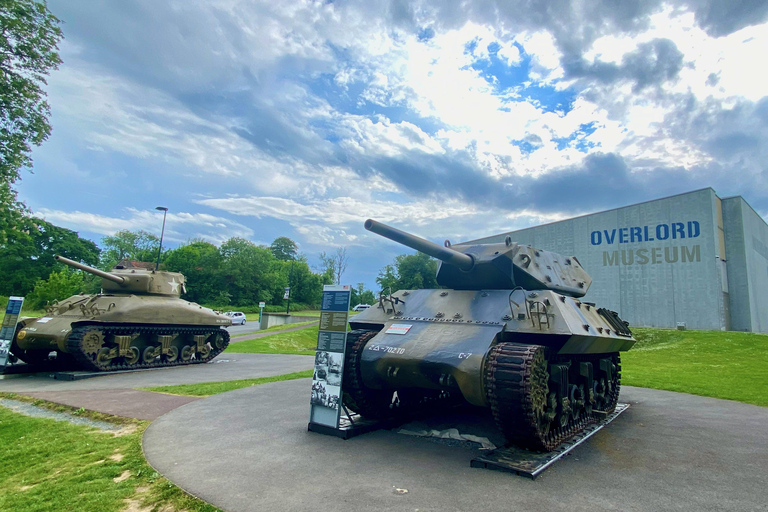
left=18, top=0, right=768, bottom=289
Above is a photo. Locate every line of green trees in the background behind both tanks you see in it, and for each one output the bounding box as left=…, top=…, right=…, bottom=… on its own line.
left=0, top=223, right=437, bottom=310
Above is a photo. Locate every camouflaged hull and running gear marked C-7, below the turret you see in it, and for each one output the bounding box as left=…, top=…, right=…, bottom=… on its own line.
left=345, top=288, right=635, bottom=449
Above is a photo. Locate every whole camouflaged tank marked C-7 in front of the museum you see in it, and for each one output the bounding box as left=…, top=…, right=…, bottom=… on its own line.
left=344, top=219, right=635, bottom=451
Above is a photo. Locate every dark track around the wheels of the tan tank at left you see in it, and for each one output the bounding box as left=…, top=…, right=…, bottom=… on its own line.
left=67, top=324, right=229, bottom=371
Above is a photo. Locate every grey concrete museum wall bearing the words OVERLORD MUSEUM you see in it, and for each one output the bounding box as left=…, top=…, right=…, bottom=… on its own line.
left=474, top=188, right=728, bottom=329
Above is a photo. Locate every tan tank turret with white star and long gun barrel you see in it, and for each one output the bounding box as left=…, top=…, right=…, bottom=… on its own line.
left=54, top=255, right=186, bottom=297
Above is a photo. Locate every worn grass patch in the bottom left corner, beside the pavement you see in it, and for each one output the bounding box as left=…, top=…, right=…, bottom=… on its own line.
left=0, top=407, right=218, bottom=512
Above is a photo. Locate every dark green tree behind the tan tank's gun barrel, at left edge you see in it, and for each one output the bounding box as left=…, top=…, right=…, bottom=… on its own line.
left=0, top=217, right=100, bottom=295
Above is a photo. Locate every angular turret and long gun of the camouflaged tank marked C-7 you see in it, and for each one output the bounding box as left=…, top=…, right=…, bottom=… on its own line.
left=365, top=219, right=592, bottom=297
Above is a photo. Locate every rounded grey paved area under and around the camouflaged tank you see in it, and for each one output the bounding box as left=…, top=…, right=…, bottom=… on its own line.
left=144, top=379, right=768, bottom=512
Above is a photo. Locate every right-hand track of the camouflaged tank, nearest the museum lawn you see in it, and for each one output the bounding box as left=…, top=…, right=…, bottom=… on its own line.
left=485, top=342, right=621, bottom=451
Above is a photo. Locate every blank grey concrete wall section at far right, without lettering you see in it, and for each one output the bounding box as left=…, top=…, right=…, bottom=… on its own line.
left=723, top=197, right=768, bottom=332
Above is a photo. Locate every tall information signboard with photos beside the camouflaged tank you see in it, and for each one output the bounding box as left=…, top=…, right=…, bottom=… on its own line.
left=309, top=285, right=351, bottom=428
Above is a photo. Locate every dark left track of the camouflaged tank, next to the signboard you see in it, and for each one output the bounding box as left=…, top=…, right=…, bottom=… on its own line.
left=343, top=329, right=397, bottom=419
